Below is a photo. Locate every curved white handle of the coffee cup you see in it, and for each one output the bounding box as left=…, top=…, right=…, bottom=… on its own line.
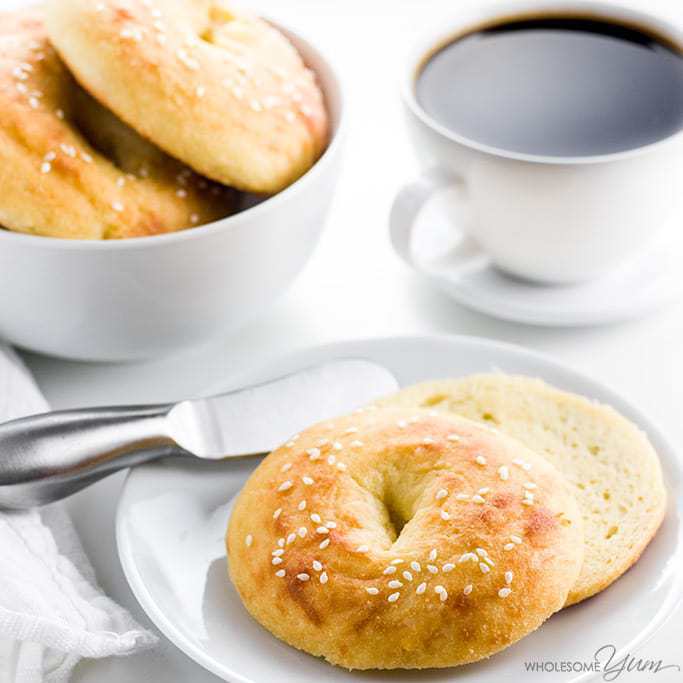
left=389, top=166, right=489, bottom=274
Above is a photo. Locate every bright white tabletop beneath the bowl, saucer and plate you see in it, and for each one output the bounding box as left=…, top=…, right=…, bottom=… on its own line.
left=14, top=0, right=683, bottom=683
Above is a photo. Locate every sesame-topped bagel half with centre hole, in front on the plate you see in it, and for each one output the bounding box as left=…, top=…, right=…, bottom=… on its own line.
left=227, top=411, right=583, bottom=669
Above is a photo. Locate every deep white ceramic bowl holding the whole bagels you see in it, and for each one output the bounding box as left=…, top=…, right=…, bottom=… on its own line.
left=0, top=21, right=345, bottom=361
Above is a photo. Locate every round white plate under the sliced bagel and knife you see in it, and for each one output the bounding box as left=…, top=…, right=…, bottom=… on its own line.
left=116, top=337, right=683, bottom=683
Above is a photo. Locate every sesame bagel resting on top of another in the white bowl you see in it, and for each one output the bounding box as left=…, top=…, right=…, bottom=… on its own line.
left=48, top=0, right=328, bottom=194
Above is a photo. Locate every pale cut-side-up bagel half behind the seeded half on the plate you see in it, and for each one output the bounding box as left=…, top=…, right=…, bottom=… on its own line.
left=374, top=373, right=667, bottom=605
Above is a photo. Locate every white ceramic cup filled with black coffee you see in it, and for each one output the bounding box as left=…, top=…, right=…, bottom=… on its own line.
left=391, top=0, right=683, bottom=283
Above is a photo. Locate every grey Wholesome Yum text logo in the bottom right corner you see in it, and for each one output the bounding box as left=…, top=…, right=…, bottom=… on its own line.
left=524, top=645, right=681, bottom=683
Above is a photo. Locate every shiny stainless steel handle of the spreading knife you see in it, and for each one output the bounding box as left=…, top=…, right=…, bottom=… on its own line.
left=0, top=405, right=183, bottom=510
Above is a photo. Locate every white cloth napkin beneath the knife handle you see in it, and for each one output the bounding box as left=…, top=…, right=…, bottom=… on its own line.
left=0, top=346, right=157, bottom=683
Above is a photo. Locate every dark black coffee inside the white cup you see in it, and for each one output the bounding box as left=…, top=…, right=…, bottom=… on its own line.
left=416, top=16, right=683, bottom=156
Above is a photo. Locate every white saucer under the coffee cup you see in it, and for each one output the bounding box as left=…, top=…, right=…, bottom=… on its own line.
left=400, top=193, right=683, bottom=327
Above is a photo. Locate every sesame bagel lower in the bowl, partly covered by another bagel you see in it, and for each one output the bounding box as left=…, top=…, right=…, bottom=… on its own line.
left=0, top=9, right=237, bottom=239
